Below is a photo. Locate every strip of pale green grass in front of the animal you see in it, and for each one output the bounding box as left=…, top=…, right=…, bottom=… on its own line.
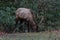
left=0, top=31, right=60, bottom=40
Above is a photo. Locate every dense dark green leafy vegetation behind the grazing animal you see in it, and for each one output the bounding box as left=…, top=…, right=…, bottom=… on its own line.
left=0, top=0, right=60, bottom=32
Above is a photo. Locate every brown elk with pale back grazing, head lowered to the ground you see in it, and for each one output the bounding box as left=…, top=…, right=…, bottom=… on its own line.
left=13, top=8, right=38, bottom=32
